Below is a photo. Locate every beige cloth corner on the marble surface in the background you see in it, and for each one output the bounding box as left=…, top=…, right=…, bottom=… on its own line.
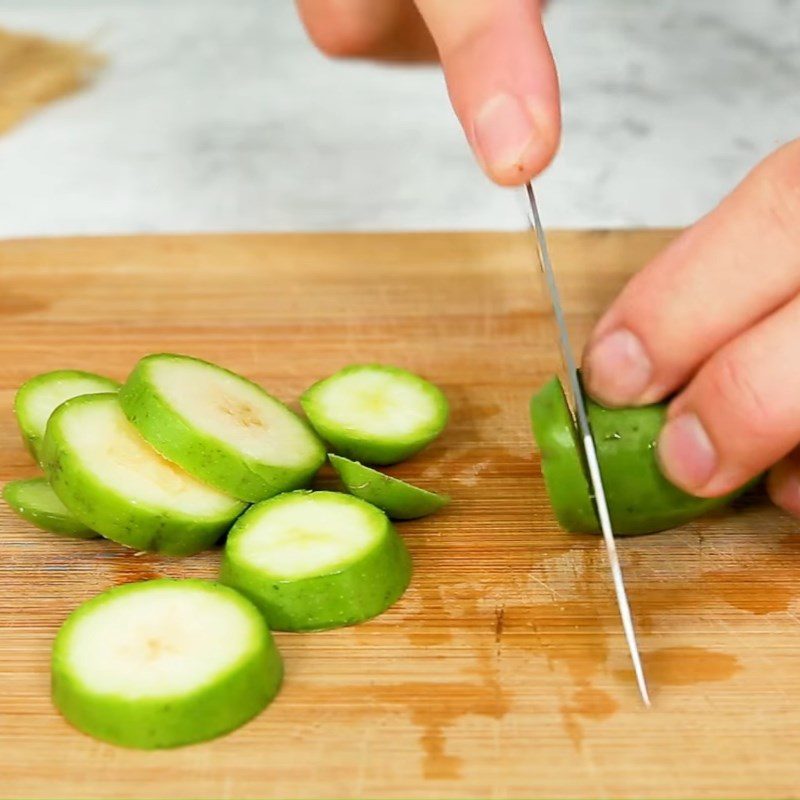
left=0, top=28, right=104, bottom=133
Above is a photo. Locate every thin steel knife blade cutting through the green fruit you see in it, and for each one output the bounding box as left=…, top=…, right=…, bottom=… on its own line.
left=525, top=183, right=650, bottom=707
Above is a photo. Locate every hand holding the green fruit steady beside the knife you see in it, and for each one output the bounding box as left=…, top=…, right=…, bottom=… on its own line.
left=584, top=139, right=800, bottom=516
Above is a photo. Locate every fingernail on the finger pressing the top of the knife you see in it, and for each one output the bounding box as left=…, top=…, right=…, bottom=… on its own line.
left=473, top=94, right=540, bottom=177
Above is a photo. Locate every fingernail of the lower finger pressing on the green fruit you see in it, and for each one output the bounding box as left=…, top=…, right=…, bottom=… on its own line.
left=658, top=413, right=717, bottom=492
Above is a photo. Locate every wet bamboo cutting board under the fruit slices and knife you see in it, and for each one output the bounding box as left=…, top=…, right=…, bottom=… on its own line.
left=0, top=232, right=800, bottom=798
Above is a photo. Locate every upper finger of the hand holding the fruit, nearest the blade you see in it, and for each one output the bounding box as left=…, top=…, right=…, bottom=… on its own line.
left=584, top=139, right=800, bottom=405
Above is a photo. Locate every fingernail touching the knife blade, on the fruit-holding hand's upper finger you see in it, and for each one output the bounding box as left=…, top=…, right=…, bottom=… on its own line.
left=584, top=328, right=653, bottom=406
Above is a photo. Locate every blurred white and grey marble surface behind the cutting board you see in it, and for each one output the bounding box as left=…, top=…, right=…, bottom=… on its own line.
left=0, top=0, right=800, bottom=236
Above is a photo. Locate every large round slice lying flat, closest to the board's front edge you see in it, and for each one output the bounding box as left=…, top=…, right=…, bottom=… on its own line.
left=52, top=579, right=283, bottom=749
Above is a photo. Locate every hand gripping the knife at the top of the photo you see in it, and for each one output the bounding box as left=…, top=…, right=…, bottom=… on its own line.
left=296, top=0, right=561, bottom=186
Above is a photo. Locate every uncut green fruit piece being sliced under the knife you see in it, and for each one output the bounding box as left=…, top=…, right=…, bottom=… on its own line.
left=531, top=378, right=752, bottom=535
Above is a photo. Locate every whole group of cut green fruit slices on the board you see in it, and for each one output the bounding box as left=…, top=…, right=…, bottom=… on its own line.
left=3, top=354, right=448, bottom=748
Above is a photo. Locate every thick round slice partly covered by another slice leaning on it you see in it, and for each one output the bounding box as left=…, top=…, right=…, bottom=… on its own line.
left=43, top=394, right=245, bottom=555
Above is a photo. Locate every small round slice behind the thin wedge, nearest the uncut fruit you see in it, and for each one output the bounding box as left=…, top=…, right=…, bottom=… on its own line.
left=301, top=364, right=449, bottom=464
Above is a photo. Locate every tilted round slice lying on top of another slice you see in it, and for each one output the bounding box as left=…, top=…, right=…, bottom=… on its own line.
left=120, top=355, right=325, bottom=502
